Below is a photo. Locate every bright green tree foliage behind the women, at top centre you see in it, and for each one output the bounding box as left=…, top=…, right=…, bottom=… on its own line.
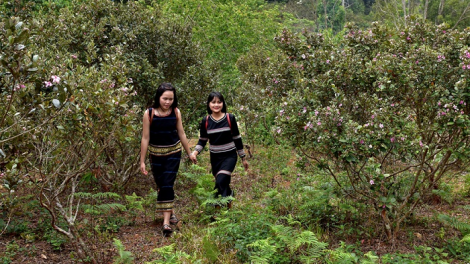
left=160, top=0, right=282, bottom=92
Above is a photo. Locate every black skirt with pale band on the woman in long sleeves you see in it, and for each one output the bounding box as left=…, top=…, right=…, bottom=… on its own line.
left=210, top=150, right=237, bottom=197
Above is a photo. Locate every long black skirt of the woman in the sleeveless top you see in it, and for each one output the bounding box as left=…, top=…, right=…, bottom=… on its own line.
left=150, top=151, right=181, bottom=212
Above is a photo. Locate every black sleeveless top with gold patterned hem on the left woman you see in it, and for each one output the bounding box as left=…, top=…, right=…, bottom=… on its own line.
left=148, top=108, right=181, bottom=156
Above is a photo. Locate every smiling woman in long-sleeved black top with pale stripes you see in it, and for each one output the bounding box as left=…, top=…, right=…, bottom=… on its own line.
left=193, top=92, right=248, bottom=208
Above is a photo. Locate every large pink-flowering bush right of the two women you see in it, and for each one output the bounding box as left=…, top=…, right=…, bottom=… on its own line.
left=239, top=19, right=470, bottom=243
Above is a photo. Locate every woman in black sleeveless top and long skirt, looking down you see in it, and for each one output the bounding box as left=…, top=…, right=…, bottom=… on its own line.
left=140, top=83, right=196, bottom=233
